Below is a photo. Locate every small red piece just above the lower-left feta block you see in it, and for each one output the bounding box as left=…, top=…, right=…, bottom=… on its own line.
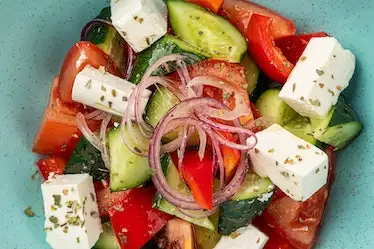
left=36, top=157, right=67, bottom=180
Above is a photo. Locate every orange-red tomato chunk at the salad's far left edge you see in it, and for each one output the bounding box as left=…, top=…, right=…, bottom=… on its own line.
left=33, top=108, right=81, bottom=157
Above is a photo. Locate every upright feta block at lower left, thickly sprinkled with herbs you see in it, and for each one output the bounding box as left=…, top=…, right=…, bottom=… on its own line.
left=42, top=174, right=102, bottom=249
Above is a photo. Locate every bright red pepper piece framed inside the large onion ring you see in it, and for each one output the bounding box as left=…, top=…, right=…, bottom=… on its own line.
left=172, top=151, right=213, bottom=210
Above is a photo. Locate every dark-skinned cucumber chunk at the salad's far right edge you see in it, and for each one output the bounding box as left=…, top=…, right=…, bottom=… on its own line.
left=312, top=96, right=363, bottom=150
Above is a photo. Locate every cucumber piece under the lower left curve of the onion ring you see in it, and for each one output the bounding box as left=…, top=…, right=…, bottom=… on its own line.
left=153, top=155, right=215, bottom=230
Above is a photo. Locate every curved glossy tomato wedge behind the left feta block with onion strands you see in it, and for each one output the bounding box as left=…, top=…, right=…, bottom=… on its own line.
left=59, top=41, right=121, bottom=104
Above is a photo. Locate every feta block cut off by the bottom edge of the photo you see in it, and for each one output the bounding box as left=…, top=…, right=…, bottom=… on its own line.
left=214, top=225, right=269, bottom=249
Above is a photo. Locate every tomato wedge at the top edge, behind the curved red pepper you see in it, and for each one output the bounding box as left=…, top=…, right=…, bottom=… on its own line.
left=220, top=0, right=296, bottom=38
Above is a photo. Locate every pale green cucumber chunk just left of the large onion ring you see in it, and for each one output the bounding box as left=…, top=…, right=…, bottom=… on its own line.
left=108, top=126, right=151, bottom=192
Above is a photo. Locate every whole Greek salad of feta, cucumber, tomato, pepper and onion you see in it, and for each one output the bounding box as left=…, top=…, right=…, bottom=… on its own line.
left=33, top=0, right=362, bottom=249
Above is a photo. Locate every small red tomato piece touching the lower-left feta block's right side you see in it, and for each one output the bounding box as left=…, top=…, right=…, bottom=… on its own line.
left=94, top=181, right=129, bottom=217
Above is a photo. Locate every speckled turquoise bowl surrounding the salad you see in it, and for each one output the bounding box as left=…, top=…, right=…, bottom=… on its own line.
left=0, top=0, right=374, bottom=249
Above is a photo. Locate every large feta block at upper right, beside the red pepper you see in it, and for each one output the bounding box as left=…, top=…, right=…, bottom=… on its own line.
left=279, top=37, right=356, bottom=118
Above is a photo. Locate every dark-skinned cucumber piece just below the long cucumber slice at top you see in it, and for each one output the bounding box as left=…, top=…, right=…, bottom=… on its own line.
left=129, top=34, right=206, bottom=84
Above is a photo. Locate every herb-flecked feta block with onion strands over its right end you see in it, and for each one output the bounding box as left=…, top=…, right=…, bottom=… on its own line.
left=72, top=66, right=151, bottom=117
